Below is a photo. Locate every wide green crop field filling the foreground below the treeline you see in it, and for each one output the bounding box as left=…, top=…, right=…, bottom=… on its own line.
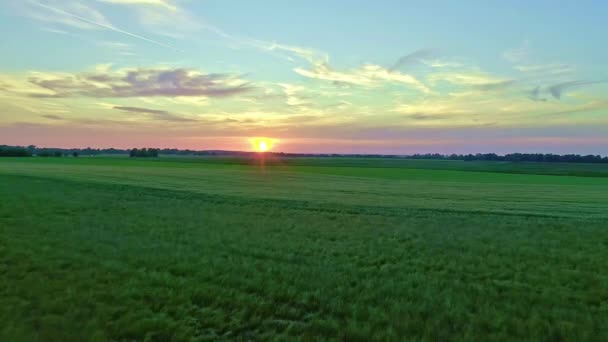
left=0, top=157, right=608, bottom=341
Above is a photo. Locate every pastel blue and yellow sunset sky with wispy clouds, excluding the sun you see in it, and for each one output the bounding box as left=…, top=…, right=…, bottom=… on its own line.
left=0, top=0, right=608, bottom=155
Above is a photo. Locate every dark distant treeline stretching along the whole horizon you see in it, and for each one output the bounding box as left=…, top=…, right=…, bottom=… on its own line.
left=0, top=145, right=608, bottom=163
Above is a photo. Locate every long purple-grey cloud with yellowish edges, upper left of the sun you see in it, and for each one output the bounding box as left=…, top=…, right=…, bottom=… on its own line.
left=29, top=69, right=253, bottom=98
